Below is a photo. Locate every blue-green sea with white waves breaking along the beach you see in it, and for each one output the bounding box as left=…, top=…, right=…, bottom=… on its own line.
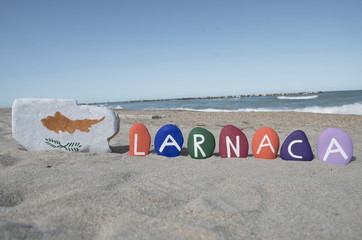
left=97, top=90, right=362, bottom=115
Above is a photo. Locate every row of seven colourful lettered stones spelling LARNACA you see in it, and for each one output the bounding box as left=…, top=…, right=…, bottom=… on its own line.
left=129, top=123, right=353, bottom=165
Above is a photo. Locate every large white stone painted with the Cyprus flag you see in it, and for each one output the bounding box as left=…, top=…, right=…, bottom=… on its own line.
left=12, top=98, right=119, bottom=153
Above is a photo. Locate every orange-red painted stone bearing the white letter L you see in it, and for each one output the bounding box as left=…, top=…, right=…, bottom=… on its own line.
left=128, top=123, right=151, bottom=157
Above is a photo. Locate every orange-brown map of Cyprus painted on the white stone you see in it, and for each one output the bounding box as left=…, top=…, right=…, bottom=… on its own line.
left=41, top=112, right=105, bottom=134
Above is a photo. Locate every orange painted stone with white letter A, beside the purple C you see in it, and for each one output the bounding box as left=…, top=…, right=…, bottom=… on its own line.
left=251, top=127, right=279, bottom=159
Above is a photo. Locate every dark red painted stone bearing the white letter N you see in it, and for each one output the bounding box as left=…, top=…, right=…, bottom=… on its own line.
left=219, top=125, right=249, bottom=158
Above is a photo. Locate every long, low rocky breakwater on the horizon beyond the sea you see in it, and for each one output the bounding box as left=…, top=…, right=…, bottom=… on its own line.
left=124, top=91, right=322, bottom=103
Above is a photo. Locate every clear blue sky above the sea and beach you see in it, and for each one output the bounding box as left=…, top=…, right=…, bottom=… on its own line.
left=0, top=0, right=362, bottom=107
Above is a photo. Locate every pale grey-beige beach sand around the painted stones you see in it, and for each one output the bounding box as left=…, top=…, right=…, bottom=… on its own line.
left=0, top=109, right=362, bottom=239
